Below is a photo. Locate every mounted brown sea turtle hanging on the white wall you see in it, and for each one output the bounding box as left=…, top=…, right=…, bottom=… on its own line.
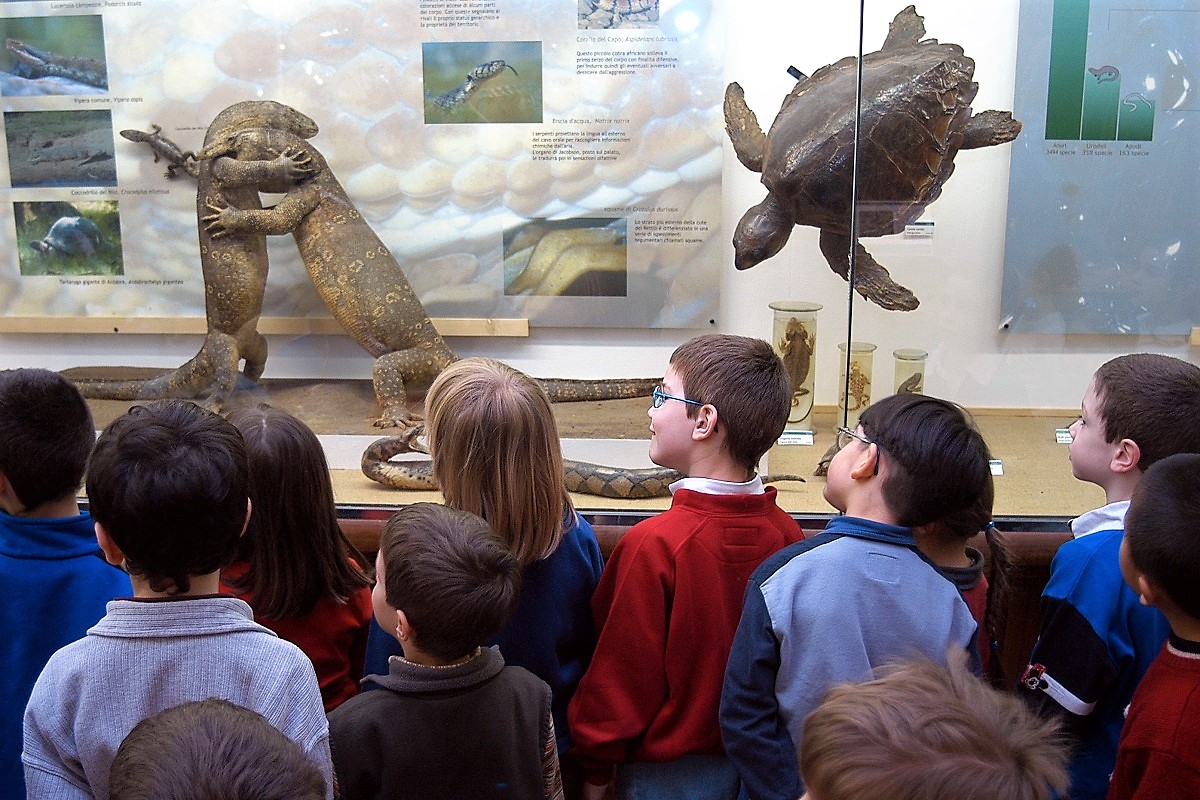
left=725, top=6, right=1021, bottom=311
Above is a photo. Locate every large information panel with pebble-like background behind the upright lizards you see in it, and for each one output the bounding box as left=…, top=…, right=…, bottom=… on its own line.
left=0, top=0, right=725, bottom=327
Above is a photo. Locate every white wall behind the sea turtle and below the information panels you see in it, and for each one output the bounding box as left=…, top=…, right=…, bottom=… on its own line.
left=0, top=0, right=1198, bottom=408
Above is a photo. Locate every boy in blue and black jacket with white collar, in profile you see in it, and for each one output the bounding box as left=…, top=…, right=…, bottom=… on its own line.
left=1020, top=353, right=1200, bottom=800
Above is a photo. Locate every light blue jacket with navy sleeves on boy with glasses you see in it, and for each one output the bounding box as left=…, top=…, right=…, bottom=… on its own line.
left=720, top=517, right=978, bottom=800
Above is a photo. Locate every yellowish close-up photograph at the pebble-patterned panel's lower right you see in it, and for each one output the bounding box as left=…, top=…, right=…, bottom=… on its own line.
left=504, top=217, right=629, bottom=297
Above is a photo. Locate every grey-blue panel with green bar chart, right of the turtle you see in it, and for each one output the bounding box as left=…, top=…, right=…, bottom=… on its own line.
left=998, top=0, right=1200, bottom=336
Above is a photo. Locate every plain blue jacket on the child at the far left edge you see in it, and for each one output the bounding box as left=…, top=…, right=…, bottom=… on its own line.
left=0, top=512, right=133, bottom=798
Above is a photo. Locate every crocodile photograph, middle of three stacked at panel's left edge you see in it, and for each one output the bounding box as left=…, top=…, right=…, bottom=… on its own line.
left=4, top=109, right=116, bottom=188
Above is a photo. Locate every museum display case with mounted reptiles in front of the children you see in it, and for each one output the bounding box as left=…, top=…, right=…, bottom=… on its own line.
left=0, top=0, right=1200, bottom=530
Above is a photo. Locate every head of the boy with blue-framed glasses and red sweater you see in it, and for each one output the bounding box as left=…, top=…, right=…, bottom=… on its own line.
left=650, top=333, right=792, bottom=474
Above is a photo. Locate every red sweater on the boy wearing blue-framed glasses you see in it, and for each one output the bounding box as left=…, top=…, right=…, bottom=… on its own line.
left=569, top=487, right=803, bottom=784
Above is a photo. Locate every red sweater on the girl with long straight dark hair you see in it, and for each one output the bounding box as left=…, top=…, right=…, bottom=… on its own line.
left=221, top=561, right=371, bottom=712
